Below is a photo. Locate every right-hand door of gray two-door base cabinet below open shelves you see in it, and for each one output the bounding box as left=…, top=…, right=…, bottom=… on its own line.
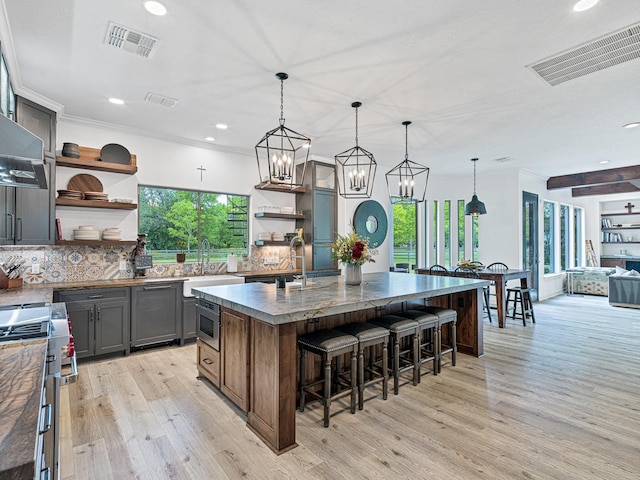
left=94, top=299, right=130, bottom=355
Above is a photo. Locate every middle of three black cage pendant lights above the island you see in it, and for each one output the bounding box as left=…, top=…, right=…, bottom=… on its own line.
left=335, top=102, right=376, bottom=198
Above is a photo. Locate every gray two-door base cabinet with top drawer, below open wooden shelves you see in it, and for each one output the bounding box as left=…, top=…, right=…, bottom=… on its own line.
left=57, top=288, right=130, bottom=358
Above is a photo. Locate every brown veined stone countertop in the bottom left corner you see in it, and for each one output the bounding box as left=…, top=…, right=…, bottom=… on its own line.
left=0, top=340, right=47, bottom=479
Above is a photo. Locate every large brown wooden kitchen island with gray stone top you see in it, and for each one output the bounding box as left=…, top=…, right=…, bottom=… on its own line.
left=193, top=272, right=489, bottom=453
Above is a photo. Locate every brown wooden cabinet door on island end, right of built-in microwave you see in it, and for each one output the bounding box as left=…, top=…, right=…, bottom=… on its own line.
left=220, top=308, right=249, bottom=412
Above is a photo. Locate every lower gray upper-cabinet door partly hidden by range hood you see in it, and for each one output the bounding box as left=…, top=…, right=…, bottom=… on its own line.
left=15, top=160, right=56, bottom=245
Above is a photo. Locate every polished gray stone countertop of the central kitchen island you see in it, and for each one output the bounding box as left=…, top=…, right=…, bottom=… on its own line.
left=193, top=272, right=489, bottom=325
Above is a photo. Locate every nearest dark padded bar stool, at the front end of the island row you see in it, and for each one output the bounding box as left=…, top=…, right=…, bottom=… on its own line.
left=298, top=329, right=358, bottom=427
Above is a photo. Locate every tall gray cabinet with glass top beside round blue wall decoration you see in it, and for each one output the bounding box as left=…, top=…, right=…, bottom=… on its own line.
left=296, top=161, right=338, bottom=270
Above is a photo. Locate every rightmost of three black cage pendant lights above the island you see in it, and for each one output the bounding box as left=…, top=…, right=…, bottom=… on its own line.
left=385, top=121, right=429, bottom=203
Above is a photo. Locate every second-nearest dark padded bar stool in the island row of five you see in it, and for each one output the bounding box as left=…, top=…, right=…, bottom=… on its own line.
left=336, top=322, right=389, bottom=410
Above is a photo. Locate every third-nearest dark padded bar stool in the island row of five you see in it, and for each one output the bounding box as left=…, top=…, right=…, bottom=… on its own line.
left=369, top=315, right=420, bottom=395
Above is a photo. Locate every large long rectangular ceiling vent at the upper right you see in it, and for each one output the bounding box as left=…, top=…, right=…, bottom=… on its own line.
left=527, top=23, right=640, bottom=86
